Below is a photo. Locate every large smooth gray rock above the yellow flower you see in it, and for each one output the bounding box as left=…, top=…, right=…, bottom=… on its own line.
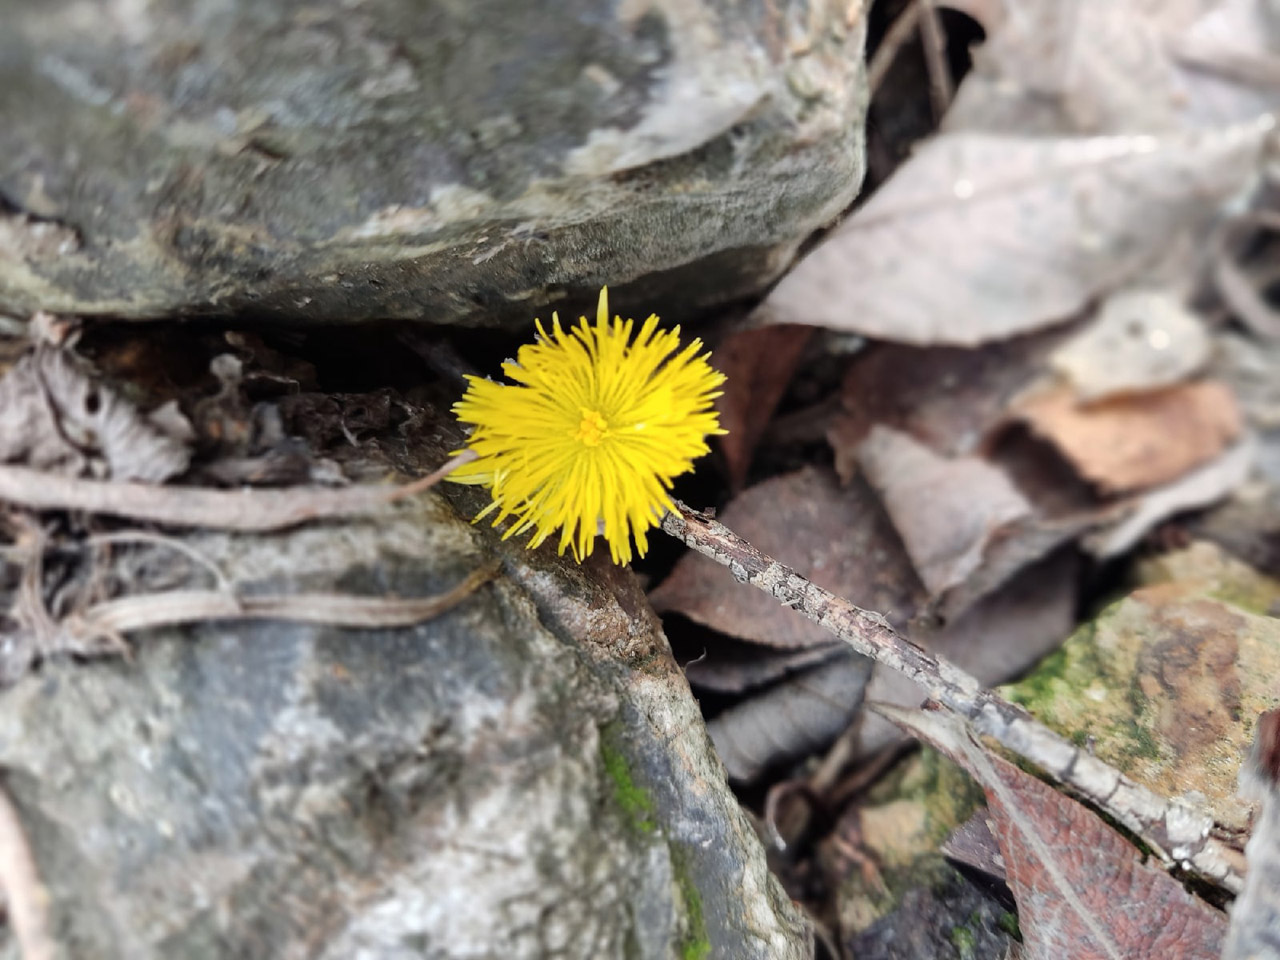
left=0, top=0, right=867, bottom=325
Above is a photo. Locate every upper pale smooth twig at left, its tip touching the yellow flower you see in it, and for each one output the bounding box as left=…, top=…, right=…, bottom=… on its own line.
left=0, top=451, right=475, bottom=532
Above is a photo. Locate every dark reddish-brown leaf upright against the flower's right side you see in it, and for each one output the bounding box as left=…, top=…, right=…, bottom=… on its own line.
left=716, top=324, right=813, bottom=492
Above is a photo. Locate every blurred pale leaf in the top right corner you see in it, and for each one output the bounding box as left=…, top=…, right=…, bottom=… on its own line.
left=946, top=0, right=1276, bottom=133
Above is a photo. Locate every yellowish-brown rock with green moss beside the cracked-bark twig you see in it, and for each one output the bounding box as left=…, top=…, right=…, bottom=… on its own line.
left=1002, top=544, right=1280, bottom=829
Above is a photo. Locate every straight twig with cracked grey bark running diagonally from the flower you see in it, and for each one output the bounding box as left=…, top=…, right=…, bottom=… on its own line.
left=662, top=502, right=1243, bottom=892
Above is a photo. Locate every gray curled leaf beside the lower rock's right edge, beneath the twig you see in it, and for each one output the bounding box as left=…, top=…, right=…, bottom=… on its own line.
left=707, top=650, right=872, bottom=782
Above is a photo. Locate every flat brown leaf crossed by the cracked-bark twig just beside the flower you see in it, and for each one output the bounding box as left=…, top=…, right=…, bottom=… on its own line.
left=649, top=467, right=924, bottom=648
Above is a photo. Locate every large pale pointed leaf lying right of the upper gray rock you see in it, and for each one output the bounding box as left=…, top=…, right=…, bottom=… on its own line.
left=760, top=120, right=1271, bottom=344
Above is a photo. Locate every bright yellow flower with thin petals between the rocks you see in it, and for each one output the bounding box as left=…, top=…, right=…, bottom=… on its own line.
left=449, top=288, right=724, bottom=563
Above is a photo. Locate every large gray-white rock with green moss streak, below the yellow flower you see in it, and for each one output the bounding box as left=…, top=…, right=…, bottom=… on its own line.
left=0, top=490, right=812, bottom=960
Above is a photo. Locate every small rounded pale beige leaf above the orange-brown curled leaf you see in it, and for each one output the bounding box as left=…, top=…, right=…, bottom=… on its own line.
left=1050, top=289, right=1212, bottom=401
